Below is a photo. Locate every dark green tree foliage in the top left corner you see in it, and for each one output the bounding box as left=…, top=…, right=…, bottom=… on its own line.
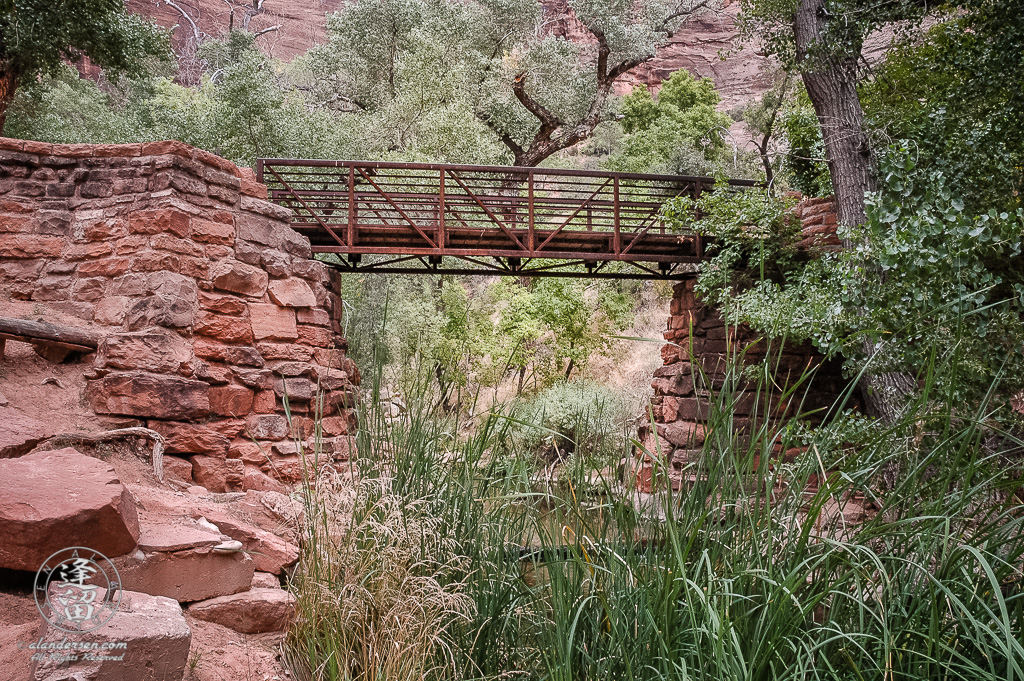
left=0, top=0, right=168, bottom=132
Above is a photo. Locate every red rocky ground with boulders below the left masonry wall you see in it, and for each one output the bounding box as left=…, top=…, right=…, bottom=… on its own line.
left=0, top=335, right=302, bottom=681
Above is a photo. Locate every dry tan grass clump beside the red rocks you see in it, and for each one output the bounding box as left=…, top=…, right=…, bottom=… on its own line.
left=288, top=476, right=473, bottom=681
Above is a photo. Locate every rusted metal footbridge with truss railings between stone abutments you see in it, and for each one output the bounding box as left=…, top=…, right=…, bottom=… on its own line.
left=256, top=159, right=755, bottom=279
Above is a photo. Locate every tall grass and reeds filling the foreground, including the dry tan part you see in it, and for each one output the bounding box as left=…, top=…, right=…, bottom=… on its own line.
left=287, top=342, right=1024, bottom=681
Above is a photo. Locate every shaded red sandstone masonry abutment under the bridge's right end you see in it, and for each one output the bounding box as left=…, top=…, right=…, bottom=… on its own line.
left=635, top=198, right=847, bottom=490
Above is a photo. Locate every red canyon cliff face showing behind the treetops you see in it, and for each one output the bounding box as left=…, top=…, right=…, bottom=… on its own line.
left=128, top=0, right=769, bottom=111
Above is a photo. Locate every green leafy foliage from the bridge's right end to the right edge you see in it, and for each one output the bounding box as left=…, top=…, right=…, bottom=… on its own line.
left=668, top=147, right=1024, bottom=417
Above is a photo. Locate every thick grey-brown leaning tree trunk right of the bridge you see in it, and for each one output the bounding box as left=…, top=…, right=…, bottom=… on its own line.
left=793, top=0, right=916, bottom=423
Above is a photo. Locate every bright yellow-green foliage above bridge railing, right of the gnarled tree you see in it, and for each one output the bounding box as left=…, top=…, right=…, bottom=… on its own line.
left=605, top=70, right=731, bottom=174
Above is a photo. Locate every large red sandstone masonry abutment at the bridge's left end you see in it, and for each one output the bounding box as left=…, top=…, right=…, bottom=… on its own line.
left=0, top=138, right=359, bottom=491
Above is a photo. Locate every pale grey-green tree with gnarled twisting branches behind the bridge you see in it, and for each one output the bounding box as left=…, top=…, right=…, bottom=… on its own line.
left=311, top=0, right=710, bottom=166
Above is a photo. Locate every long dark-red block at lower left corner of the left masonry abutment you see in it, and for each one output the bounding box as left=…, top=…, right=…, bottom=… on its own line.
left=89, top=372, right=210, bottom=421
